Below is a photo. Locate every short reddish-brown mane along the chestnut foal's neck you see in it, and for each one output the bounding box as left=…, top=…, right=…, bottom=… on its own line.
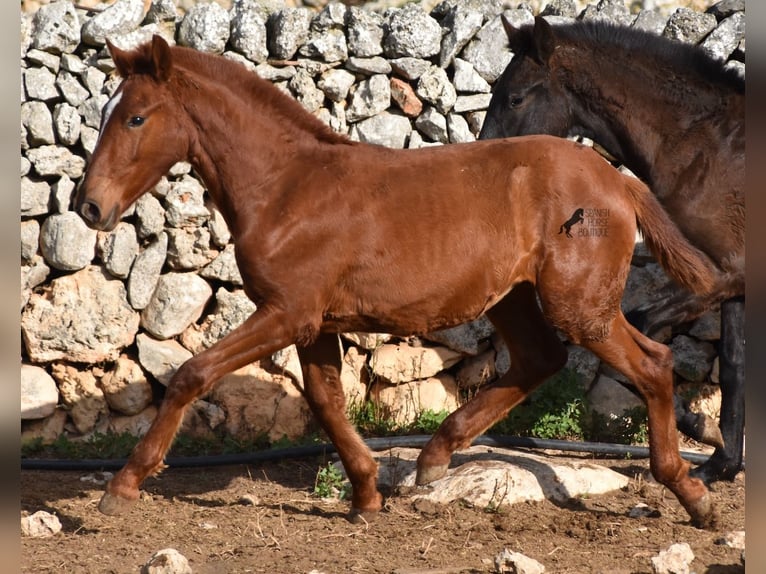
left=171, top=46, right=351, bottom=143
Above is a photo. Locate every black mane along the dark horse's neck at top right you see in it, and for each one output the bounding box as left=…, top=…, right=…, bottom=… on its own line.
left=548, top=21, right=745, bottom=93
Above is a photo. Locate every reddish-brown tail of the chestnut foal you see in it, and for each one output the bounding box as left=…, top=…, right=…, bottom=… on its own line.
left=624, top=175, right=716, bottom=294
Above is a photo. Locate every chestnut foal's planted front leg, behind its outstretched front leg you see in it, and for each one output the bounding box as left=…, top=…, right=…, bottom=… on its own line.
left=298, top=333, right=383, bottom=521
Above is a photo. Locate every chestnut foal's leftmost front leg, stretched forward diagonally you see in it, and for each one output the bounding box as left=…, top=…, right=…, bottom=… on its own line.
left=99, top=307, right=296, bottom=514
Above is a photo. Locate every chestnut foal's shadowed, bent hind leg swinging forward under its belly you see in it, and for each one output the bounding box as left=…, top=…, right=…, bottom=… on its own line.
left=416, top=283, right=567, bottom=484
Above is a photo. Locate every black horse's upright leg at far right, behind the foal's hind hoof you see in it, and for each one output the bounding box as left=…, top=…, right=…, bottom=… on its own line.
left=691, top=297, right=745, bottom=483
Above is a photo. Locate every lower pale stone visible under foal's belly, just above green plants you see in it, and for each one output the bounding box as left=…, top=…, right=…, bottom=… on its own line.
left=370, top=374, right=459, bottom=426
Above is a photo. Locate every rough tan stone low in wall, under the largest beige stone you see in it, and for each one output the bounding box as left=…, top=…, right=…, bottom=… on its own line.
left=51, top=363, right=109, bottom=434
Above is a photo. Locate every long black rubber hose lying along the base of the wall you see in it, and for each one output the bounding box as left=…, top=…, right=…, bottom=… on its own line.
left=21, top=435, right=716, bottom=470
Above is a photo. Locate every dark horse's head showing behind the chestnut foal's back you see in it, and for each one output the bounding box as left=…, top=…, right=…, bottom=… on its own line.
left=479, top=16, right=571, bottom=139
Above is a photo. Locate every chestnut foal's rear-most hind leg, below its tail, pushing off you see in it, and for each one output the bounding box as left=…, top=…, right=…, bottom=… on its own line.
left=583, top=313, right=716, bottom=527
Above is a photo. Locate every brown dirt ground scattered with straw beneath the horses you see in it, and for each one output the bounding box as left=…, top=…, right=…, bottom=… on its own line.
left=21, top=458, right=745, bottom=574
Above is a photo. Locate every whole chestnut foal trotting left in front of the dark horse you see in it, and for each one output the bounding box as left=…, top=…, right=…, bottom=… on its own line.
left=76, top=36, right=715, bottom=525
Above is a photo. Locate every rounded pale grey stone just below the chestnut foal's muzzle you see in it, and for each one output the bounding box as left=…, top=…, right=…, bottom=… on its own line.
left=40, top=211, right=97, bottom=271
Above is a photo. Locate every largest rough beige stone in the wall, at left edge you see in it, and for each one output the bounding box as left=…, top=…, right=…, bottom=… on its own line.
left=21, top=266, right=138, bottom=363
